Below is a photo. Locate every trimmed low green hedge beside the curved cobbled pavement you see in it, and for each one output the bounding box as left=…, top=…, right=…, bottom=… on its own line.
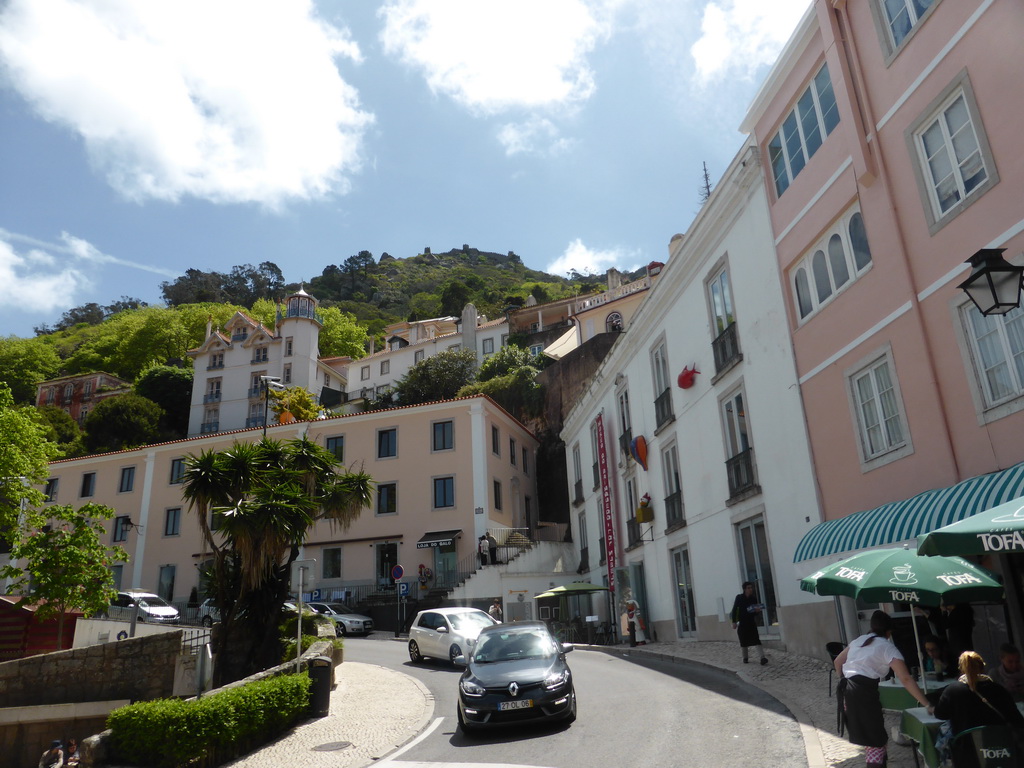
left=106, top=672, right=309, bottom=768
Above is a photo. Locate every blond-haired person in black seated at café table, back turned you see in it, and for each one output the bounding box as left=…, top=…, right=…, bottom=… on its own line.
left=935, top=650, right=1024, bottom=767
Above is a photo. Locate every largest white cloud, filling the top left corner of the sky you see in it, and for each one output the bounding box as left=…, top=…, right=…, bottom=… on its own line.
left=0, top=0, right=373, bottom=206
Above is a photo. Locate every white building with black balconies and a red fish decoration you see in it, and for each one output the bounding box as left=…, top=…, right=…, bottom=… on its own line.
left=562, top=145, right=819, bottom=642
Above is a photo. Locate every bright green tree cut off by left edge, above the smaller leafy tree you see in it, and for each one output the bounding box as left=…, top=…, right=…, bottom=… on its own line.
left=0, top=383, right=60, bottom=544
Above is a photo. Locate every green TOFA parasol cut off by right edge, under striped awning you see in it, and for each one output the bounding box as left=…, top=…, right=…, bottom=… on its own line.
left=918, top=499, right=1024, bottom=555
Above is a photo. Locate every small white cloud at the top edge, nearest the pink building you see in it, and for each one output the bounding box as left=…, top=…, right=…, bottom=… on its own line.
left=690, top=0, right=808, bottom=85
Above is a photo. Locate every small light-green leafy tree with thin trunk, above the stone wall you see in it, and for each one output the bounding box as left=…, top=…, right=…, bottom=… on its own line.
left=0, top=504, right=128, bottom=647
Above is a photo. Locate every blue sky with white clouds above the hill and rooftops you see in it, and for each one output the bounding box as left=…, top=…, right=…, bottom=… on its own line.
left=0, top=0, right=809, bottom=337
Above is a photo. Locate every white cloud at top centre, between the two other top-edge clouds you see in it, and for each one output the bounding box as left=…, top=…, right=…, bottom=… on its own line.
left=380, top=0, right=609, bottom=115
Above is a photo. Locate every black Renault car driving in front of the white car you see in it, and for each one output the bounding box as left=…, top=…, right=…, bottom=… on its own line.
left=456, top=622, right=577, bottom=733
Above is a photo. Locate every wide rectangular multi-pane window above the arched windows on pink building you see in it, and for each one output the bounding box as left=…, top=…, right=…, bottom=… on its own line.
left=768, top=65, right=839, bottom=197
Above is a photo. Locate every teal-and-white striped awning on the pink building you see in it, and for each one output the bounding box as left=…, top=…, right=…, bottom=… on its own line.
left=793, top=463, right=1024, bottom=562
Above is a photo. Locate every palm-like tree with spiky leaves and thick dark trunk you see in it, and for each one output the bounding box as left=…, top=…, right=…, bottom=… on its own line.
left=183, top=438, right=373, bottom=682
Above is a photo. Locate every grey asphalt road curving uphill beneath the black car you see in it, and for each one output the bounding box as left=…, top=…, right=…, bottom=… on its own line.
left=345, top=638, right=807, bottom=768
